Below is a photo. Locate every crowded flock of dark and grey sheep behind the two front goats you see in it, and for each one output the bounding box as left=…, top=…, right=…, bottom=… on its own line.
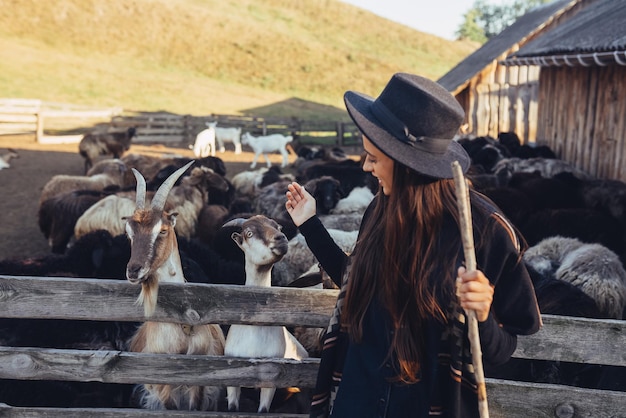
left=0, top=131, right=626, bottom=413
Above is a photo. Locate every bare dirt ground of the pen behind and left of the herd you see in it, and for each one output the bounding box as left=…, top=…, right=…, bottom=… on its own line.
left=0, top=135, right=296, bottom=259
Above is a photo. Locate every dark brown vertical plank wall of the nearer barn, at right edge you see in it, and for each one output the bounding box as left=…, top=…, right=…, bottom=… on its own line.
left=537, top=65, right=626, bottom=181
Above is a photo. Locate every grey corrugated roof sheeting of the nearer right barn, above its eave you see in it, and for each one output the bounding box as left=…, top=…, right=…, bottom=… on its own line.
left=511, top=0, right=626, bottom=58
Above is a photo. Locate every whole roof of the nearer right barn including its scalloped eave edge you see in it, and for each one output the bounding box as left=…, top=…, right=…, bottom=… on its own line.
left=505, top=0, right=626, bottom=66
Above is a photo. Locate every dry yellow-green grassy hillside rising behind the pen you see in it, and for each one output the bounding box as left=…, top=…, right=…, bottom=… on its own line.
left=0, top=0, right=477, bottom=119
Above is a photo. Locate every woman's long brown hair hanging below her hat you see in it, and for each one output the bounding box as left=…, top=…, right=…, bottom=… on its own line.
left=342, top=163, right=462, bottom=383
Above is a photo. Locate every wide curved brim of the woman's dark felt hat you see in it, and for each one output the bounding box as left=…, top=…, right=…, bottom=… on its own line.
left=344, top=91, right=471, bottom=179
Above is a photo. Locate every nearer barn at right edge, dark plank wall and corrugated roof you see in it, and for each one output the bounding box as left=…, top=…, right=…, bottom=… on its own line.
left=503, top=0, right=626, bottom=181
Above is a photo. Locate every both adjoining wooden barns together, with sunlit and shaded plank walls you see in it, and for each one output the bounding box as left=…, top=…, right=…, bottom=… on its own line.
left=438, top=0, right=626, bottom=181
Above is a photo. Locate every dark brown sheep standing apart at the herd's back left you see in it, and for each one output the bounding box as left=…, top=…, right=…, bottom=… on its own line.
left=78, top=127, right=137, bottom=173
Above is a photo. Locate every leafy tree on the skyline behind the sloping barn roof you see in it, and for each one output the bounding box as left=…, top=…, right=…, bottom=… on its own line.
left=456, top=0, right=552, bottom=43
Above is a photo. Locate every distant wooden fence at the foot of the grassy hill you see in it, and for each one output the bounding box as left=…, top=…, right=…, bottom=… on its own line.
left=0, top=99, right=360, bottom=147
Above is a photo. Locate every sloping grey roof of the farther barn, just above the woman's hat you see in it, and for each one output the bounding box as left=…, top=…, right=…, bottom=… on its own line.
left=437, top=0, right=576, bottom=94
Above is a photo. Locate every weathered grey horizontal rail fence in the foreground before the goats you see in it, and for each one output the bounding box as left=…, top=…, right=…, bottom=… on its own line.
left=0, top=276, right=626, bottom=418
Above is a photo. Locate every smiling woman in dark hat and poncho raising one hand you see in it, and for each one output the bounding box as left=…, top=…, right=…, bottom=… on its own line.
left=285, top=73, right=541, bottom=418
